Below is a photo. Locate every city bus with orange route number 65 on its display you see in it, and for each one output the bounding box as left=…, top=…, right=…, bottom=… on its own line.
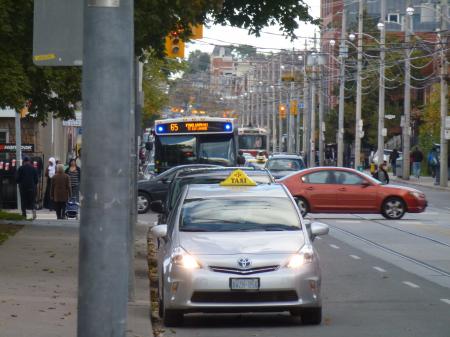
left=154, top=116, right=237, bottom=174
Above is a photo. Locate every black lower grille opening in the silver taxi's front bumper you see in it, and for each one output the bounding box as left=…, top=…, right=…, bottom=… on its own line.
left=191, top=290, right=298, bottom=303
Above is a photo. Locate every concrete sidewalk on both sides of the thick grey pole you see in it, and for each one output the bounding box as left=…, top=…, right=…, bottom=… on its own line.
left=0, top=220, right=153, bottom=337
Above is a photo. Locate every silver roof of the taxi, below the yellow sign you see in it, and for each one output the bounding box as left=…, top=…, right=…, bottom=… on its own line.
left=186, top=184, right=288, bottom=199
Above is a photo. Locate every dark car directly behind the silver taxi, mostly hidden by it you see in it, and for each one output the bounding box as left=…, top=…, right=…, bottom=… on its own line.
left=150, top=167, right=275, bottom=223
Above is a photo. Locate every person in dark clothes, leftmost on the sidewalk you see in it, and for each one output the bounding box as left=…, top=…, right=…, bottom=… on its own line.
left=16, top=157, right=39, bottom=219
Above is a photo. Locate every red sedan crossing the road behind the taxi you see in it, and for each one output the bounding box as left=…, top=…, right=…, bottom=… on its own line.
left=278, top=167, right=427, bottom=219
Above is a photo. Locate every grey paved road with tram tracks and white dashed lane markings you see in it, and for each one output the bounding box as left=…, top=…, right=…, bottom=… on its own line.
left=150, top=184, right=450, bottom=337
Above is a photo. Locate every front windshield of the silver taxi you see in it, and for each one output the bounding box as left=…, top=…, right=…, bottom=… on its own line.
left=180, top=197, right=301, bottom=232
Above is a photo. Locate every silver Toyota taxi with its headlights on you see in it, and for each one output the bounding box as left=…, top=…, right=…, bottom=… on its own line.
left=152, top=180, right=328, bottom=326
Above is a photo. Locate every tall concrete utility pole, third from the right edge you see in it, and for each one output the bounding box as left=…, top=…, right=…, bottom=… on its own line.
left=378, top=0, right=386, bottom=168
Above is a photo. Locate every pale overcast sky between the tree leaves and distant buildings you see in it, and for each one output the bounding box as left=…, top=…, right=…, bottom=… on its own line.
left=186, top=0, right=320, bottom=56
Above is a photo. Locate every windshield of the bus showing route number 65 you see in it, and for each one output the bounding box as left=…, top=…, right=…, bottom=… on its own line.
left=155, top=134, right=236, bottom=169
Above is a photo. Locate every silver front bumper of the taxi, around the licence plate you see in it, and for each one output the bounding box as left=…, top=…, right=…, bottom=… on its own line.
left=164, top=262, right=321, bottom=312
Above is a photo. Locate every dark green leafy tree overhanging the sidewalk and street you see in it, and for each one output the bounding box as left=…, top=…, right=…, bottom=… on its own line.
left=0, top=0, right=318, bottom=122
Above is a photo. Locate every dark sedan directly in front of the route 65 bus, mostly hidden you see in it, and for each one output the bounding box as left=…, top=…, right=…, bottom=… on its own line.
left=137, top=164, right=221, bottom=214
